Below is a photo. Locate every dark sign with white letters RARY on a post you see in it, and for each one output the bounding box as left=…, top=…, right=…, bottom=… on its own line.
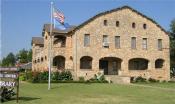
left=0, top=68, right=19, bottom=102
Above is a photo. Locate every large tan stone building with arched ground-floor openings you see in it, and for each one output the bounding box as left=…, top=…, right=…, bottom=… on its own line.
left=32, top=6, right=170, bottom=81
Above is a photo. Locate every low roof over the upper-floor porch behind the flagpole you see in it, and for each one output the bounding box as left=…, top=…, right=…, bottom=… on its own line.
left=43, top=24, right=76, bottom=34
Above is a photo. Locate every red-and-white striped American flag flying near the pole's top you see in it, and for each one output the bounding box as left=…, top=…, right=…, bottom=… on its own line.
left=53, top=8, right=65, bottom=24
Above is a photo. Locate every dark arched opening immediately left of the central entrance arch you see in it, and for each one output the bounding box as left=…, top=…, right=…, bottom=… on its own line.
left=80, top=56, right=92, bottom=69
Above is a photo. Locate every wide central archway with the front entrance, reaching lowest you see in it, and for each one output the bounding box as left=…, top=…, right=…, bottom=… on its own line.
left=99, top=57, right=122, bottom=75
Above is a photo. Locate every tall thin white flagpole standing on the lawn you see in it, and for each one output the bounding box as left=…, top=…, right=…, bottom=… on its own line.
left=48, top=2, right=53, bottom=90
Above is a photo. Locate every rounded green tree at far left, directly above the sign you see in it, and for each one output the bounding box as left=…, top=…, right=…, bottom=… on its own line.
left=1, top=52, right=16, bottom=67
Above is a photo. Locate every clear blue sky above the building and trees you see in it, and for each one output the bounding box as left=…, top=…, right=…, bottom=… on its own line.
left=0, top=0, right=175, bottom=59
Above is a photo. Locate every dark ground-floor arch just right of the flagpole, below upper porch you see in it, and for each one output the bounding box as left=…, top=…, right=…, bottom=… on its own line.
left=53, top=56, right=65, bottom=70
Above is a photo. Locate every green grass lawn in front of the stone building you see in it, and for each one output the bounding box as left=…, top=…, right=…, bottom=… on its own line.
left=4, top=83, right=175, bottom=104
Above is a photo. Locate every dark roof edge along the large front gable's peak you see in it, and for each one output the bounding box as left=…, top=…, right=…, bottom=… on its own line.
left=72, top=6, right=168, bottom=34
